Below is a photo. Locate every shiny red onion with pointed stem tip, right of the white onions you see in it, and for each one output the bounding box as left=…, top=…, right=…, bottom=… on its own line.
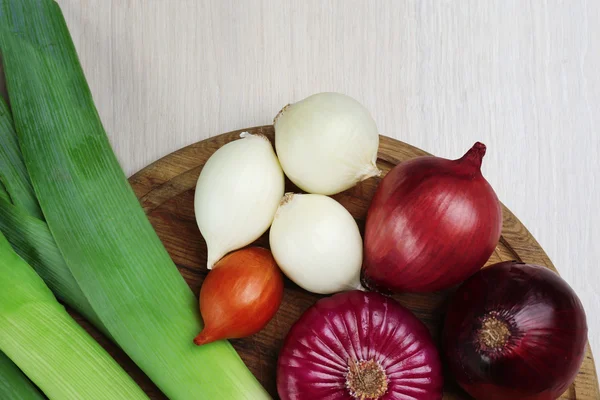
left=363, top=143, right=502, bottom=292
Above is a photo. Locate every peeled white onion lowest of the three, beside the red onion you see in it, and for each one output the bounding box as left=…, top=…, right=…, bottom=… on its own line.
left=269, top=193, right=363, bottom=294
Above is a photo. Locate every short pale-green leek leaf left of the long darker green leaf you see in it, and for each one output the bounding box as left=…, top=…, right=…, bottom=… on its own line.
left=0, top=234, right=147, bottom=400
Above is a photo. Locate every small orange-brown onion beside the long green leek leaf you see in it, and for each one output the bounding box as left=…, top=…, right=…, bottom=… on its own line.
left=194, top=247, right=283, bottom=345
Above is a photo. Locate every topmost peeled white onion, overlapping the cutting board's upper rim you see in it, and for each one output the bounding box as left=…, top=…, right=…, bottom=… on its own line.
left=274, top=93, right=380, bottom=195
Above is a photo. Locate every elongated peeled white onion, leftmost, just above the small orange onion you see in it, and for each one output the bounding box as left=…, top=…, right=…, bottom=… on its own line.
left=194, top=132, right=284, bottom=269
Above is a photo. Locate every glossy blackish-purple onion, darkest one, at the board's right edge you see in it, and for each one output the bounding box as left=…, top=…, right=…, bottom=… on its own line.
left=443, top=262, right=587, bottom=400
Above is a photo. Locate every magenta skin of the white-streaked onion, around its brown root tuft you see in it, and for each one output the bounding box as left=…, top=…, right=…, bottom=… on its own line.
left=277, top=291, right=443, bottom=400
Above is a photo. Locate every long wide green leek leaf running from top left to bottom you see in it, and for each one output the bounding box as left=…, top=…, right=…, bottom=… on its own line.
left=0, top=0, right=269, bottom=400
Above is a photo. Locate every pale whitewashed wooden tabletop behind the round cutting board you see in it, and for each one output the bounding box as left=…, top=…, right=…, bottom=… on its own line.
left=41, top=0, right=600, bottom=376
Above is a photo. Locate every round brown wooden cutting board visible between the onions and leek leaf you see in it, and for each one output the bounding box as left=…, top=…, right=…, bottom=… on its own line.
left=86, top=126, right=600, bottom=400
